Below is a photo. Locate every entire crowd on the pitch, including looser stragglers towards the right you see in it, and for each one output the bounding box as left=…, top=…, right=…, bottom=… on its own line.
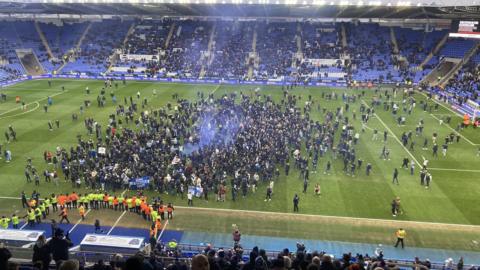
left=2, top=80, right=476, bottom=223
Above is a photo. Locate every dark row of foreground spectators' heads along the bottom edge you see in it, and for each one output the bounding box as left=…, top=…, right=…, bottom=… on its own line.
left=0, top=238, right=477, bottom=270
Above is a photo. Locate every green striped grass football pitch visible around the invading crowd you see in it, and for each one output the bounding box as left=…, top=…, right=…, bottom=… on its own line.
left=0, top=80, right=480, bottom=250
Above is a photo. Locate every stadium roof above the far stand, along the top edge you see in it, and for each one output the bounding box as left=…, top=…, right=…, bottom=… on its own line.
left=0, top=0, right=480, bottom=19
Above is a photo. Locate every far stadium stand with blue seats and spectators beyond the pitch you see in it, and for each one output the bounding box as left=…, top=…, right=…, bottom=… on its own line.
left=0, top=19, right=478, bottom=83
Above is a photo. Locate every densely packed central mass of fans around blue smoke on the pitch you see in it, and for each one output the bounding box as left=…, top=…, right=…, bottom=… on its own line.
left=37, top=87, right=356, bottom=201
